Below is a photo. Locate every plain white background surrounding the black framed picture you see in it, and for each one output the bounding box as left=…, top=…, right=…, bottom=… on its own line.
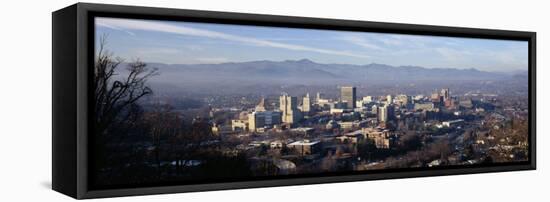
left=0, top=0, right=550, bottom=202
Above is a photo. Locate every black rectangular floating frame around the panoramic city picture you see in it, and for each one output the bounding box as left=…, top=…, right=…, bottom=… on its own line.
left=52, top=3, right=536, bottom=199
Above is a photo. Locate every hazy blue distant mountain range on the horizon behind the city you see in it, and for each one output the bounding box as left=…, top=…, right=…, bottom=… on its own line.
left=135, top=59, right=523, bottom=84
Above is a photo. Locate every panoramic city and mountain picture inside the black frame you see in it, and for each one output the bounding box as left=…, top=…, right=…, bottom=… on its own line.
left=89, top=17, right=529, bottom=188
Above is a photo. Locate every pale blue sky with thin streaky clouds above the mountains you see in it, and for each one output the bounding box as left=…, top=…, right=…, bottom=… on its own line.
left=95, top=17, right=528, bottom=72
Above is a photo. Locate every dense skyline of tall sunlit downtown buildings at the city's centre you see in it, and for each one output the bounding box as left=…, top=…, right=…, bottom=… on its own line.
left=227, top=86, right=462, bottom=130
